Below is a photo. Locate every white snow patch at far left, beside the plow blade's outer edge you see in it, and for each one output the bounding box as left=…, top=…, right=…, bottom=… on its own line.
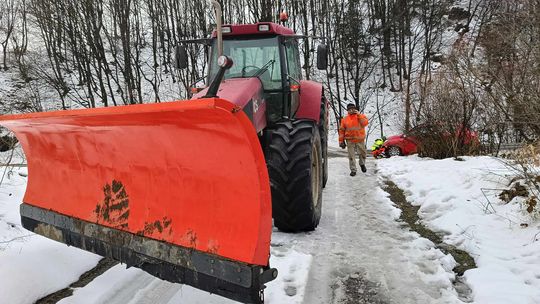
left=0, top=162, right=100, bottom=303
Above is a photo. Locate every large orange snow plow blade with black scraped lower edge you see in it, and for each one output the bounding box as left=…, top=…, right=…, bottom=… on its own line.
left=0, top=98, right=277, bottom=303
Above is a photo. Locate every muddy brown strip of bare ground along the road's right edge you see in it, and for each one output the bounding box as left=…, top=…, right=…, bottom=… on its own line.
left=383, top=180, right=476, bottom=303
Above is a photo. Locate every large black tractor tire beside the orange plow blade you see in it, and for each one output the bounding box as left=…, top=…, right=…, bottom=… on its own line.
left=266, top=120, right=323, bottom=232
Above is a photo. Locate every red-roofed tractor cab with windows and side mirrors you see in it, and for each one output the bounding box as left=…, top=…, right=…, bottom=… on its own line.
left=177, top=22, right=327, bottom=123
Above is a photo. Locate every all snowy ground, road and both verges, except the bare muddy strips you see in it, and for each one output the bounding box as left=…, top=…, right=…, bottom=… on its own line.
left=0, top=149, right=540, bottom=304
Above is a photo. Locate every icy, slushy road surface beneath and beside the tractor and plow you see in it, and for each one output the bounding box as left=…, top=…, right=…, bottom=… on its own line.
left=53, top=151, right=460, bottom=304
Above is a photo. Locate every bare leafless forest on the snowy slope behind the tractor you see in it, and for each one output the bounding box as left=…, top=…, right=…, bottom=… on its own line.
left=0, top=0, right=540, bottom=153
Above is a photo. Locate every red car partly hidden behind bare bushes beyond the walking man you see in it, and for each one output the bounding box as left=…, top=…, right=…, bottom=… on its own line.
left=384, top=125, right=480, bottom=157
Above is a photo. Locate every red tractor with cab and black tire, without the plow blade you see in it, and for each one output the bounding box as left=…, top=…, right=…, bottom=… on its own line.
left=176, top=23, right=328, bottom=232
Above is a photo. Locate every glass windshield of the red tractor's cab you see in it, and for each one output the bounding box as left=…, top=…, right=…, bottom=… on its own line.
left=210, top=37, right=281, bottom=90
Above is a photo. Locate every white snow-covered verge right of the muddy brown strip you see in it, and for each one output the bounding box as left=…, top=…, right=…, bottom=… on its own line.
left=378, top=156, right=540, bottom=304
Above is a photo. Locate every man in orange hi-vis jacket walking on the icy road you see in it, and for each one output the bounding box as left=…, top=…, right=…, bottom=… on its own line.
left=339, top=103, right=368, bottom=176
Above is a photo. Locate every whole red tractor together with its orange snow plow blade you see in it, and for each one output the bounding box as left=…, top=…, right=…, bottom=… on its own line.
left=0, top=4, right=328, bottom=303
